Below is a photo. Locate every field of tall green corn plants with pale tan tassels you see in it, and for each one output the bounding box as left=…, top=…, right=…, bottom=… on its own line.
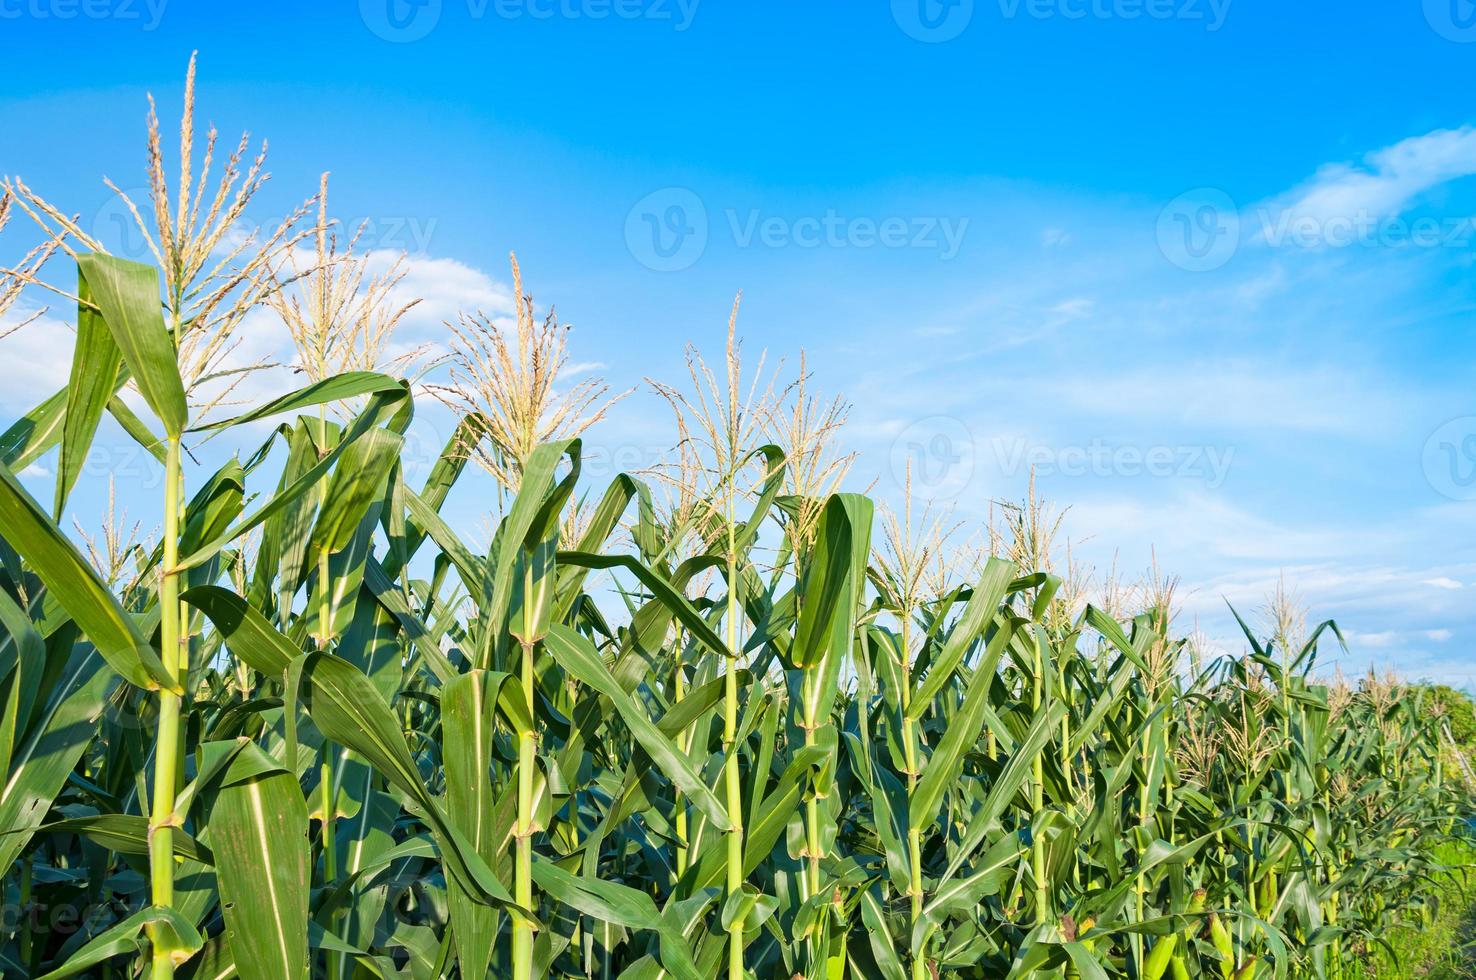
left=0, top=68, right=1470, bottom=980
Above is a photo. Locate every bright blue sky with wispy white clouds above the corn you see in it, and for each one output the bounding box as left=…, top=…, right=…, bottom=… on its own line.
left=0, top=0, right=1476, bottom=686
